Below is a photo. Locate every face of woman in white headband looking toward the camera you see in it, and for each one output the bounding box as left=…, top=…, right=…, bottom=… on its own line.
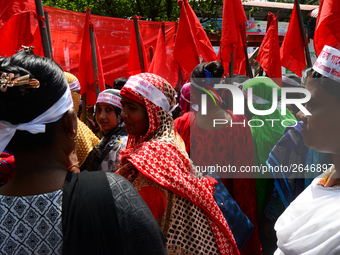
left=96, top=103, right=118, bottom=133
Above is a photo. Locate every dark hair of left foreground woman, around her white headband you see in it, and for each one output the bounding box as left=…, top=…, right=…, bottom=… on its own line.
left=0, top=51, right=68, bottom=150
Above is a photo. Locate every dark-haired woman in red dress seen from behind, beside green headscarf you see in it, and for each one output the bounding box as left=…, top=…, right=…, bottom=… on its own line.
left=175, top=61, right=261, bottom=254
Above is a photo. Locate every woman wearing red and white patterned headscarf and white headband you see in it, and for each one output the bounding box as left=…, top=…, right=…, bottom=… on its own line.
left=117, top=73, right=239, bottom=254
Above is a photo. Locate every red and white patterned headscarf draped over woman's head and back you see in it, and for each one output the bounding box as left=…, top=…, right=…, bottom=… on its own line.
left=120, top=73, right=238, bottom=254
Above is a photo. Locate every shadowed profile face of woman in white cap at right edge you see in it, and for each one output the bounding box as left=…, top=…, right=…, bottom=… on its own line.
left=297, top=78, right=340, bottom=154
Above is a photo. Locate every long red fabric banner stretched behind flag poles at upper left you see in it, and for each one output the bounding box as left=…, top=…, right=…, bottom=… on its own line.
left=0, top=6, right=177, bottom=94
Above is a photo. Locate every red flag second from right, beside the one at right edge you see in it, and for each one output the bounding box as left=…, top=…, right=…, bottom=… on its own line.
left=280, top=4, right=306, bottom=77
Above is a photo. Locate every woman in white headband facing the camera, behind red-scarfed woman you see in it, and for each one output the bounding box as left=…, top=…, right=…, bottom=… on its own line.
left=81, top=89, right=127, bottom=172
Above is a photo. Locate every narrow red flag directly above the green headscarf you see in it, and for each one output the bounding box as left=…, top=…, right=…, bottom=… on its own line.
left=256, top=12, right=282, bottom=86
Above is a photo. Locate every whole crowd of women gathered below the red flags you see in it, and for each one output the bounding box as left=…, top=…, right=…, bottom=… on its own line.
left=0, top=43, right=340, bottom=255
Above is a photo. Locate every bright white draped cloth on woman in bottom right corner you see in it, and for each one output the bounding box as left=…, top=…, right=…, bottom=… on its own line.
left=274, top=166, right=340, bottom=255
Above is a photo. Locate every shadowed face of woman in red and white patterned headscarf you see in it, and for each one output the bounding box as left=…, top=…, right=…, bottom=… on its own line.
left=120, top=96, right=149, bottom=137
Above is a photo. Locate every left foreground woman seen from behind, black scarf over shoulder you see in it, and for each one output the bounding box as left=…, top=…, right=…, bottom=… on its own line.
left=0, top=51, right=166, bottom=255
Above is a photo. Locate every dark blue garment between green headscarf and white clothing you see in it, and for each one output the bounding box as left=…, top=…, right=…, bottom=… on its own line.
left=266, top=122, right=332, bottom=207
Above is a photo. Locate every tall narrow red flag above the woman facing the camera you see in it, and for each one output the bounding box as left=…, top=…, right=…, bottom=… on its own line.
left=78, top=8, right=105, bottom=105
